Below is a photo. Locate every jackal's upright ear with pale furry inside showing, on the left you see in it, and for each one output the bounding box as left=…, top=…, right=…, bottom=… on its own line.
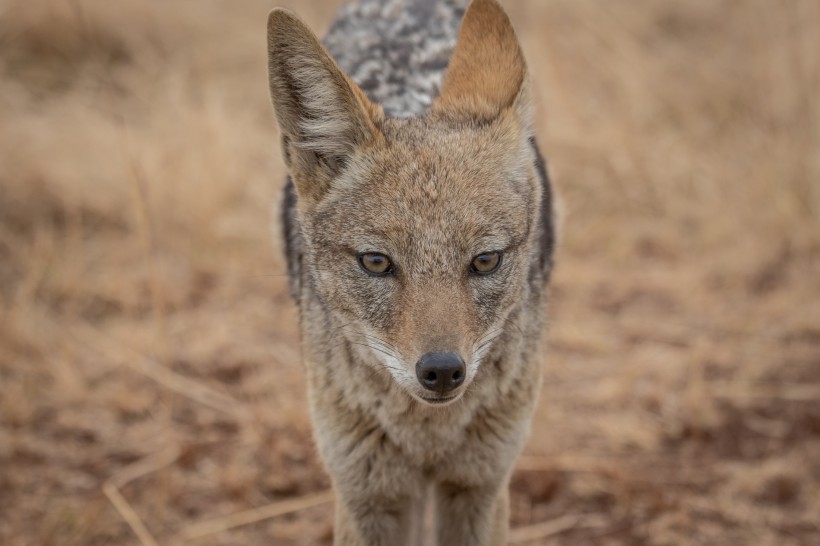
left=268, top=8, right=383, bottom=202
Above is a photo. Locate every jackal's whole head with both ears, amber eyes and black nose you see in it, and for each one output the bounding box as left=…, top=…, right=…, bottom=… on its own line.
left=269, top=0, right=540, bottom=404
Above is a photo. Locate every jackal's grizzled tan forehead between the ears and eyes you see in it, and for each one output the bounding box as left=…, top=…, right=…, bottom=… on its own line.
left=312, top=121, right=533, bottom=269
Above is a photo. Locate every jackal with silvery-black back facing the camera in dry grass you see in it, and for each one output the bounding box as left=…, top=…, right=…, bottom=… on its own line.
left=268, top=0, right=554, bottom=546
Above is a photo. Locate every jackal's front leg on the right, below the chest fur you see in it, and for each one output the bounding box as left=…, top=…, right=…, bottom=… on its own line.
left=436, top=482, right=509, bottom=546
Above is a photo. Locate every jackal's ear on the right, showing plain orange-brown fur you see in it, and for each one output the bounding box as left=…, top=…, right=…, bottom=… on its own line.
left=433, top=0, right=531, bottom=125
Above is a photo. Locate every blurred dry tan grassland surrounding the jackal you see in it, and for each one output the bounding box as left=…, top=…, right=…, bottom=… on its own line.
left=0, top=0, right=820, bottom=546
